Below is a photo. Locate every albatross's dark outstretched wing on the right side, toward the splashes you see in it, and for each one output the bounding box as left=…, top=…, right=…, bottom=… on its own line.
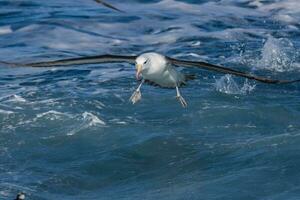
left=166, top=57, right=300, bottom=84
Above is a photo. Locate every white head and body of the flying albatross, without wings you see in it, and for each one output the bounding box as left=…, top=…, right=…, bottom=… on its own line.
left=136, top=53, right=185, bottom=88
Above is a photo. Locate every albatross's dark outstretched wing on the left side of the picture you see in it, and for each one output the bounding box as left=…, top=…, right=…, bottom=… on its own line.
left=0, top=55, right=136, bottom=67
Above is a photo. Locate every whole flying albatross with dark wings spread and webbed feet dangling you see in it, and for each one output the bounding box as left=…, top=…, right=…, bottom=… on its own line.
left=0, top=52, right=300, bottom=107
